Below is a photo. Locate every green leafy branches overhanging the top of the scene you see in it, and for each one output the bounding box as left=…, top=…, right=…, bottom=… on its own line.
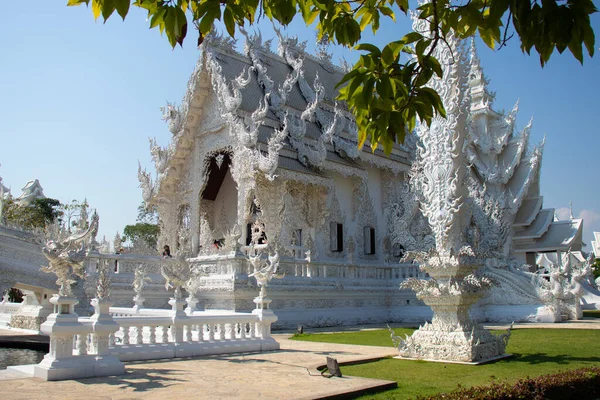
left=68, top=0, right=597, bottom=152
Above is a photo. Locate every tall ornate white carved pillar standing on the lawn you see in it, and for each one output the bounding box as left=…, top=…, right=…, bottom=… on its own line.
left=398, top=26, right=510, bottom=362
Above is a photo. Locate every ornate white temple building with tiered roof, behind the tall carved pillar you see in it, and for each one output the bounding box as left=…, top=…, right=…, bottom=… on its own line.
left=131, top=29, right=582, bottom=326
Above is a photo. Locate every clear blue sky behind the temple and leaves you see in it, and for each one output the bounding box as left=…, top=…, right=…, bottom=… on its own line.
left=0, top=0, right=600, bottom=251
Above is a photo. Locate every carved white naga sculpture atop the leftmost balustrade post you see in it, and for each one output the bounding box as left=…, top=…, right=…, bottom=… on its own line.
left=41, top=212, right=98, bottom=297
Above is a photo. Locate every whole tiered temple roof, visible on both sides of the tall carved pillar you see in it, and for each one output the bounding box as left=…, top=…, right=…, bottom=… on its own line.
left=140, top=32, right=582, bottom=258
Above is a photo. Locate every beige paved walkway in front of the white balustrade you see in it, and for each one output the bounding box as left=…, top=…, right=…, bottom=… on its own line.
left=0, top=319, right=600, bottom=400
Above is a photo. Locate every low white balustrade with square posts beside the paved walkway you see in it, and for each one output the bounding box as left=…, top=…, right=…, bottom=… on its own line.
left=34, top=296, right=279, bottom=380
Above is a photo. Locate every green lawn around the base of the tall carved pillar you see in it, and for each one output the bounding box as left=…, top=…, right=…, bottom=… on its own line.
left=296, top=329, right=600, bottom=399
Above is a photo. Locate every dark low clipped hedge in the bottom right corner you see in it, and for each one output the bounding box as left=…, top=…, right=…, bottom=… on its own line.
left=417, top=367, right=600, bottom=400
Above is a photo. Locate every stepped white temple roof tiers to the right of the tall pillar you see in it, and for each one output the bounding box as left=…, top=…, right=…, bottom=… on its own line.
left=464, top=42, right=582, bottom=253
